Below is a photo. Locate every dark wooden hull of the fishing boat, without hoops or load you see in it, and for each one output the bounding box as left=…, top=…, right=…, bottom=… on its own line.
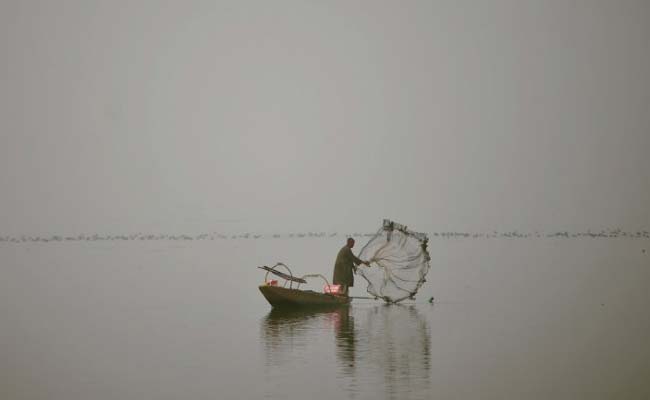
left=259, top=285, right=351, bottom=307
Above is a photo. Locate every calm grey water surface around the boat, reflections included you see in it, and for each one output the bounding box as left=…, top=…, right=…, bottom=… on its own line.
left=0, top=238, right=650, bottom=400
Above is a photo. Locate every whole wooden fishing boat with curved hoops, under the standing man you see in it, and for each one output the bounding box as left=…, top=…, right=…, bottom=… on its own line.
left=259, top=263, right=351, bottom=308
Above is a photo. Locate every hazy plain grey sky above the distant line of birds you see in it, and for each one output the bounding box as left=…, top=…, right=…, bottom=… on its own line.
left=0, top=0, right=650, bottom=234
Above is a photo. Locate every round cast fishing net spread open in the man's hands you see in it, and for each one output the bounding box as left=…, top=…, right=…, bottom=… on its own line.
left=357, top=220, right=431, bottom=303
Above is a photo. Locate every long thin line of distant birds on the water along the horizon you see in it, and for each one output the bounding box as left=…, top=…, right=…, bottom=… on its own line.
left=0, top=229, right=650, bottom=243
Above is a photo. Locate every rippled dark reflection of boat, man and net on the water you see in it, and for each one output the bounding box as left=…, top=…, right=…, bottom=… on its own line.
left=261, top=304, right=431, bottom=398
